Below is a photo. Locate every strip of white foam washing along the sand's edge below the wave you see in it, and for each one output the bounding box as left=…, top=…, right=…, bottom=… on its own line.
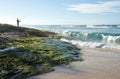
left=61, top=38, right=120, bottom=49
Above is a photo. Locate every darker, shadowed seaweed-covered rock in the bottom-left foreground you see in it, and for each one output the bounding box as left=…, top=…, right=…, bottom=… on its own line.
left=0, top=48, right=54, bottom=79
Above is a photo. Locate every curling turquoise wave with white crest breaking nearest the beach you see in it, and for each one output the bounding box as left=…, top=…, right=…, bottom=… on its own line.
left=58, top=31, right=120, bottom=44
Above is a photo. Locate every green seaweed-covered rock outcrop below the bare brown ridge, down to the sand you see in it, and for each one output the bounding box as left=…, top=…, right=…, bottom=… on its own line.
left=0, top=37, right=81, bottom=79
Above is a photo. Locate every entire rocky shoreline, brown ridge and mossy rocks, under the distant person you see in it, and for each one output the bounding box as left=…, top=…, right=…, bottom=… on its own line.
left=0, top=25, right=82, bottom=79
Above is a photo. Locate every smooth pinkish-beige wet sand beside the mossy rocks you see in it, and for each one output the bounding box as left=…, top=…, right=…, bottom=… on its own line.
left=29, top=49, right=120, bottom=79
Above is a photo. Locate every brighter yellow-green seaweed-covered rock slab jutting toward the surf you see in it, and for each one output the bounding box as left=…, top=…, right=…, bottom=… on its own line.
left=9, top=37, right=81, bottom=66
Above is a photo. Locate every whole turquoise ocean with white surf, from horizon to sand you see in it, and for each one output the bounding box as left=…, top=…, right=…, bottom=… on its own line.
left=23, top=25, right=120, bottom=49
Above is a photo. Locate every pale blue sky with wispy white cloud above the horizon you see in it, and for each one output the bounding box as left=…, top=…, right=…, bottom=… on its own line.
left=0, top=0, right=120, bottom=25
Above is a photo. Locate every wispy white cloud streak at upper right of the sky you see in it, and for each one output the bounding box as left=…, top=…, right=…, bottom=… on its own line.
left=68, top=1, right=120, bottom=13
